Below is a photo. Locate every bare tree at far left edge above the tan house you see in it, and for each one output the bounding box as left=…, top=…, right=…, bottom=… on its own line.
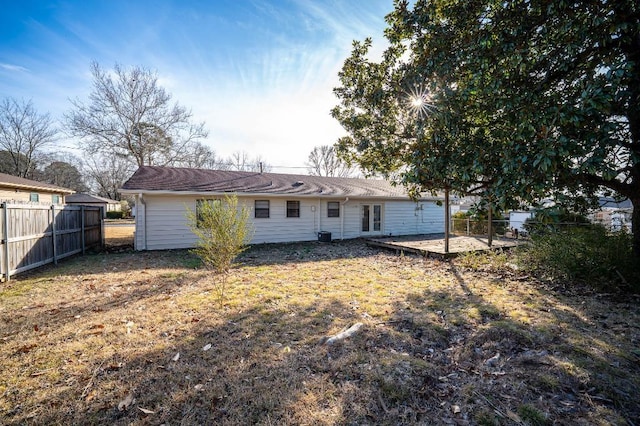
left=0, top=98, right=57, bottom=177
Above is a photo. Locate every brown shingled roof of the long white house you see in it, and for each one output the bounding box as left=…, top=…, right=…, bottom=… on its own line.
left=121, top=166, right=420, bottom=199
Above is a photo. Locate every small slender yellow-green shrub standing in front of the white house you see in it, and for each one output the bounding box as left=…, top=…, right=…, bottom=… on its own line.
left=187, top=195, right=253, bottom=307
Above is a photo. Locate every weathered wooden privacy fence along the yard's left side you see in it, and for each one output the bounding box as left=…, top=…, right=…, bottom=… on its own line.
left=0, top=203, right=104, bottom=280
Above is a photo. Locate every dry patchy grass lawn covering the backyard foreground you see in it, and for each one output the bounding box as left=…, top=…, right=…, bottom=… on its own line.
left=0, top=241, right=640, bottom=425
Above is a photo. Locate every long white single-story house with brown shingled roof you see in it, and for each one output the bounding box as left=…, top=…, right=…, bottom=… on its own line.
left=120, top=166, right=444, bottom=250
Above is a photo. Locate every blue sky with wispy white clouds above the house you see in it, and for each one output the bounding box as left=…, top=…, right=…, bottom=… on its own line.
left=0, top=0, right=393, bottom=172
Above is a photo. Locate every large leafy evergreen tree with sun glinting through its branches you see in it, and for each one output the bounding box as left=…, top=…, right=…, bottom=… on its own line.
left=332, top=0, right=640, bottom=256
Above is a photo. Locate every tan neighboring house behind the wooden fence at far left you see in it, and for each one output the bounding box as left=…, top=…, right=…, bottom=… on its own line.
left=0, top=173, right=73, bottom=205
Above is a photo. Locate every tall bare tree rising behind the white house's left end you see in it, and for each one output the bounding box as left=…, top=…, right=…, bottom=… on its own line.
left=65, top=62, right=207, bottom=166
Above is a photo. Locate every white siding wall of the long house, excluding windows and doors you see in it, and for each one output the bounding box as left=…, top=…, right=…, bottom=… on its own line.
left=135, top=194, right=444, bottom=250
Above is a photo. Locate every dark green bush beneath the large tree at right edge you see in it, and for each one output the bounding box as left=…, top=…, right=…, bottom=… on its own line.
left=516, top=225, right=640, bottom=292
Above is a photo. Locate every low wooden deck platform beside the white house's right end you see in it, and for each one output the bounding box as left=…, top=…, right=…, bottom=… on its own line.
left=366, top=234, right=522, bottom=257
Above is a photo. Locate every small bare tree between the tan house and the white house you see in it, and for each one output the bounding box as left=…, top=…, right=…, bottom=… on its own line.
left=84, top=153, right=135, bottom=200
